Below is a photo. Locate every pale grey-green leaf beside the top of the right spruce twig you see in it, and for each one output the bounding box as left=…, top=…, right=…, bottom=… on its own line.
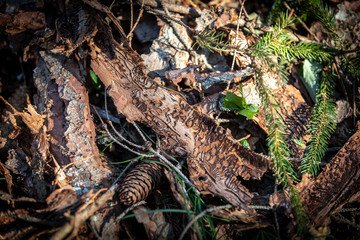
left=299, top=59, right=322, bottom=102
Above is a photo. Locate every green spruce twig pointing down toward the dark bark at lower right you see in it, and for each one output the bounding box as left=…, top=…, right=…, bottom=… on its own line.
left=301, top=69, right=336, bottom=176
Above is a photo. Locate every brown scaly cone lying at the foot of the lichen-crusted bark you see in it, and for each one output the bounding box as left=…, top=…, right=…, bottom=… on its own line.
left=119, top=162, right=164, bottom=206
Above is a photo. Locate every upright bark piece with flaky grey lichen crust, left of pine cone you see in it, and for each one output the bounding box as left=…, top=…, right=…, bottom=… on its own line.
left=34, top=52, right=111, bottom=193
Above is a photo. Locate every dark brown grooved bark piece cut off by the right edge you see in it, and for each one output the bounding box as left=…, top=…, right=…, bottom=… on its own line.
left=298, top=130, right=360, bottom=227
